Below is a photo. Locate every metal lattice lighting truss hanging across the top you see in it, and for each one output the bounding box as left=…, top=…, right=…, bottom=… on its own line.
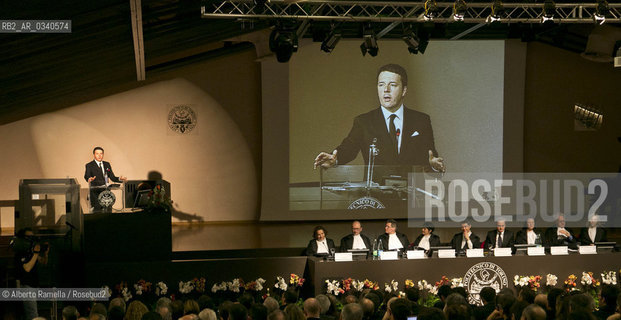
left=201, top=0, right=621, bottom=23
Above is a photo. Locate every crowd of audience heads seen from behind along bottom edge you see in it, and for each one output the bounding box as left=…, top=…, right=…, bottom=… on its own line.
left=55, top=285, right=621, bottom=320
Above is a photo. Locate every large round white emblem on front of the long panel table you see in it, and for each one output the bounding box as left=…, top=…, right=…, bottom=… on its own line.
left=462, top=262, right=509, bottom=306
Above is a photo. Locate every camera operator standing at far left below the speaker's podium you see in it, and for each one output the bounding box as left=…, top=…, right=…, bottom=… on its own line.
left=12, top=228, right=50, bottom=319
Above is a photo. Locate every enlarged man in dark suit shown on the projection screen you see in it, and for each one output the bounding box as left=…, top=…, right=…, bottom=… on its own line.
left=314, top=64, right=446, bottom=172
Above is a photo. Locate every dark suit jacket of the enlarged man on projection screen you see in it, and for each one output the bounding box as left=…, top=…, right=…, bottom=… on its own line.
left=336, top=107, right=437, bottom=167
